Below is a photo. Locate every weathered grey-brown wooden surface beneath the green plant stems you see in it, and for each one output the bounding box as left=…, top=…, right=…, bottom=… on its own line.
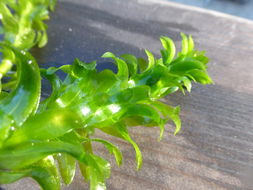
left=4, top=0, right=253, bottom=190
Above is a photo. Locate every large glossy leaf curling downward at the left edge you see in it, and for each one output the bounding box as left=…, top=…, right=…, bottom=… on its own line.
left=0, top=43, right=41, bottom=147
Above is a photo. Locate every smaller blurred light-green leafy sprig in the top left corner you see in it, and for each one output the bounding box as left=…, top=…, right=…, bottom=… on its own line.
left=0, top=0, right=56, bottom=85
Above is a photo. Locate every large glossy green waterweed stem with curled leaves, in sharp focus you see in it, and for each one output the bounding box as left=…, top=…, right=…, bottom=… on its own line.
left=0, top=1, right=212, bottom=190
